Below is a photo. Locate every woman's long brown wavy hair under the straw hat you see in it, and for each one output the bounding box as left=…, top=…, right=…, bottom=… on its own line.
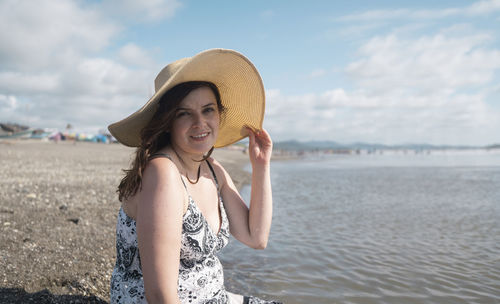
left=116, top=81, right=224, bottom=202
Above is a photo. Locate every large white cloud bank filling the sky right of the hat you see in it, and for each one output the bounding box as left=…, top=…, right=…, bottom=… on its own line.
left=316, top=0, right=500, bottom=144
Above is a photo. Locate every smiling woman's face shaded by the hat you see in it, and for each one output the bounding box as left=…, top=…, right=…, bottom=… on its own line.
left=171, top=87, right=220, bottom=155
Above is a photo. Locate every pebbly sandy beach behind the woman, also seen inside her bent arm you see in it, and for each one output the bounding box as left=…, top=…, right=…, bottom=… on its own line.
left=0, top=140, right=250, bottom=303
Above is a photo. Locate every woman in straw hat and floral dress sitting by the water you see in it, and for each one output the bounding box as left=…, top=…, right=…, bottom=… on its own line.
left=109, top=49, right=276, bottom=303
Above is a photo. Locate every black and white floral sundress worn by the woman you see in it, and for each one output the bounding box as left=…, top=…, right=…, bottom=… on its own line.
left=111, top=155, right=278, bottom=304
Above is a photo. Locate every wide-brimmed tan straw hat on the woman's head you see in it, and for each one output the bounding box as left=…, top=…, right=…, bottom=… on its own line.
left=108, top=49, right=265, bottom=148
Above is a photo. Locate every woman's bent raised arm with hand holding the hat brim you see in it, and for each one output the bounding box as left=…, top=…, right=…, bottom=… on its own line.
left=219, top=130, right=273, bottom=249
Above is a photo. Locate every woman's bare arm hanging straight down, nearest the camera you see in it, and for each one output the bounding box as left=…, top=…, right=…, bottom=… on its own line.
left=136, top=158, right=186, bottom=303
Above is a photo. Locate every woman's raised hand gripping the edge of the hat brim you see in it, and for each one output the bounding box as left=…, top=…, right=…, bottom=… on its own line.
left=248, top=128, right=273, bottom=167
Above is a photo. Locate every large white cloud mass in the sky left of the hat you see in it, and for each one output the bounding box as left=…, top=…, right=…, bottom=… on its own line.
left=0, top=0, right=171, bottom=131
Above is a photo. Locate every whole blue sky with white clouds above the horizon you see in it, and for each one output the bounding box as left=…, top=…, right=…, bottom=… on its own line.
left=0, top=0, right=500, bottom=145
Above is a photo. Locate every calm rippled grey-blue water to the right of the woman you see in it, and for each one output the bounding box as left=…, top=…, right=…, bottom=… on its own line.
left=221, top=152, right=500, bottom=303
